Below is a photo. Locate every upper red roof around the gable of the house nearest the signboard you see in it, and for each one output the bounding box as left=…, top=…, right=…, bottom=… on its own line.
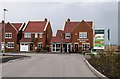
left=64, top=20, right=93, bottom=33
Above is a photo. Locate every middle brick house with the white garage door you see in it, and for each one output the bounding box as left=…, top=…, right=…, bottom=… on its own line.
left=20, top=18, right=52, bottom=52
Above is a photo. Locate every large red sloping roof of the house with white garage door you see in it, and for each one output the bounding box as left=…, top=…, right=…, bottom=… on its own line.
left=24, top=21, right=47, bottom=32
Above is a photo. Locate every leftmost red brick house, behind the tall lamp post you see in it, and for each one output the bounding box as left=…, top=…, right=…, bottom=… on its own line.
left=1, top=22, right=24, bottom=52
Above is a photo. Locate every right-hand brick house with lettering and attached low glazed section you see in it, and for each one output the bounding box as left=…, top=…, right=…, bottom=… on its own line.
left=51, top=19, right=93, bottom=52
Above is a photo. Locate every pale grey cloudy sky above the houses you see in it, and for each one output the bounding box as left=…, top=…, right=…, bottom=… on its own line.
left=0, top=0, right=118, bottom=44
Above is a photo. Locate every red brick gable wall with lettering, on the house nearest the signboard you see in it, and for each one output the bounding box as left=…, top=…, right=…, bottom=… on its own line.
left=71, top=22, right=93, bottom=47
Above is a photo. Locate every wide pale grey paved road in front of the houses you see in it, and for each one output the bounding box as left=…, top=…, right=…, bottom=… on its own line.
left=2, top=54, right=95, bottom=77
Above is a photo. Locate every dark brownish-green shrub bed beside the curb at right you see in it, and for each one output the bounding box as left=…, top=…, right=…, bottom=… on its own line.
left=88, top=52, right=120, bottom=79
